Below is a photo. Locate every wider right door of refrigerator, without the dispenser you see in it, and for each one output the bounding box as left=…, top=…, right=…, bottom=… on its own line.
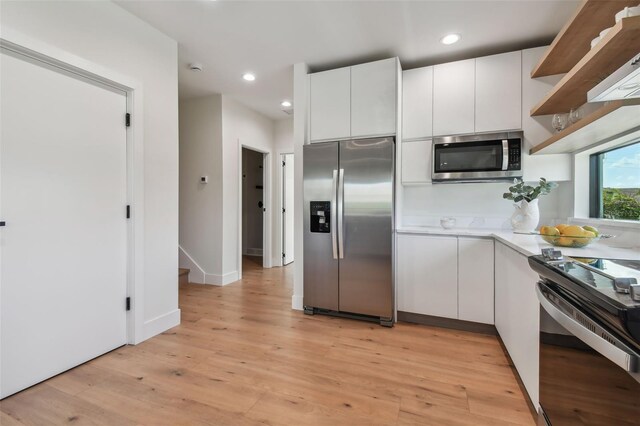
left=338, top=138, right=395, bottom=319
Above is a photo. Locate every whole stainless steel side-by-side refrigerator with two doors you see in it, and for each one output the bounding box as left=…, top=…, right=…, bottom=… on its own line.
left=304, top=138, right=395, bottom=326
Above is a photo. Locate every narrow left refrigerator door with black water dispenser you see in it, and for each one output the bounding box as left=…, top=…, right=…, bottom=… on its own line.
left=303, top=142, right=339, bottom=311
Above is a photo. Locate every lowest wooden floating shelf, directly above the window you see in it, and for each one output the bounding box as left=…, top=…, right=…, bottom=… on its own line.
left=529, top=99, right=640, bottom=155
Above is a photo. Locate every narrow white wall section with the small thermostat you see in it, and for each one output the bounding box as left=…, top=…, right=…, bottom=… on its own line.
left=180, top=95, right=222, bottom=283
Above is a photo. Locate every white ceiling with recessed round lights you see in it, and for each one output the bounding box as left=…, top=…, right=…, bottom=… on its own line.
left=117, top=0, right=578, bottom=119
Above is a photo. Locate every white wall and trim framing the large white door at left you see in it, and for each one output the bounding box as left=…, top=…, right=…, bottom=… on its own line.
left=0, top=1, right=179, bottom=337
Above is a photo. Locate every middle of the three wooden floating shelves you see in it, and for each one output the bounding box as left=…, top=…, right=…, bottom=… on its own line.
left=531, top=16, right=640, bottom=116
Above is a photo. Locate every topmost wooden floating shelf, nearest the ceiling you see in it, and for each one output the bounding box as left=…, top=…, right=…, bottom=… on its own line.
left=531, top=0, right=638, bottom=78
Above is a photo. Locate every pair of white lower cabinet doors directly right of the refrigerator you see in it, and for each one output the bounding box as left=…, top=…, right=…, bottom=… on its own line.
left=396, top=234, right=493, bottom=324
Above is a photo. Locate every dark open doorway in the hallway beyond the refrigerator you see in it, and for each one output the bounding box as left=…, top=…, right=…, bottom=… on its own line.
left=242, top=147, right=266, bottom=266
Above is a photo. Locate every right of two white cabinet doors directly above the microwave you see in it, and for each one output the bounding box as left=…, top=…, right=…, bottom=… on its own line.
left=476, top=51, right=522, bottom=133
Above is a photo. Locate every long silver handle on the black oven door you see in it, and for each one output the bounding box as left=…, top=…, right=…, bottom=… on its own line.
left=536, top=281, right=640, bottom=373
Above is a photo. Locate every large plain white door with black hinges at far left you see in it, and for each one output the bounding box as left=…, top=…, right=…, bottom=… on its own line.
left=0, top=52, right=127, bottom=397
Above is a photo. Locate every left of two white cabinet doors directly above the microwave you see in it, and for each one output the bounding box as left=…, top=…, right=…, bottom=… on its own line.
left=433, top=59, right=476, bottom=136
